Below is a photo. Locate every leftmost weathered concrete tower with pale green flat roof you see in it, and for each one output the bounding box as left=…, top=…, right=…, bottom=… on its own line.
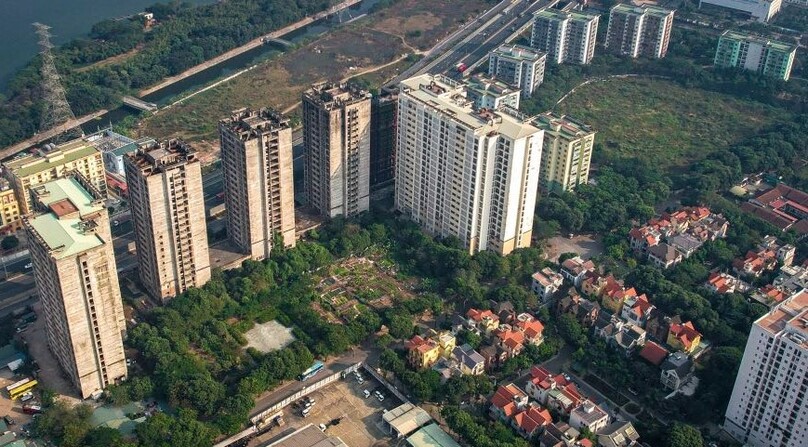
left=24, top=175, right=126, bottom=398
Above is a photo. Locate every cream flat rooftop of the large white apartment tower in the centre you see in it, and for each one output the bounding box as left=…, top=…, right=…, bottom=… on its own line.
left=401, top=74, right=539, bottom=140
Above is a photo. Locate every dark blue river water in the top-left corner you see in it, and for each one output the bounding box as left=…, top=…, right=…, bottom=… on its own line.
left=0, top=0, right=216, bottom=87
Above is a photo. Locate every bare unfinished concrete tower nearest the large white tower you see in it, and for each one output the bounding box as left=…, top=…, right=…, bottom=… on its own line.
left=303, top=84, right=371, bottom=217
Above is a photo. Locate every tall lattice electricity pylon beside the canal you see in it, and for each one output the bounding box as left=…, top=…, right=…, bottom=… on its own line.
left=34, top=22, right=84, bottom=143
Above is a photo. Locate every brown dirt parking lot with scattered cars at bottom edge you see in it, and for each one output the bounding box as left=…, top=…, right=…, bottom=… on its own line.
left=249, top=373, right=401, bottom=447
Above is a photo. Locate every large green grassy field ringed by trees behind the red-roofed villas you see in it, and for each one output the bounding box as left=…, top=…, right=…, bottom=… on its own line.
left=556, top=78, right=793, bottom=170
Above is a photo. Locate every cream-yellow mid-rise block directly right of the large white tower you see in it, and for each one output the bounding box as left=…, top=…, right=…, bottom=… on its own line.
left=533, top=112, right=595, bottom=192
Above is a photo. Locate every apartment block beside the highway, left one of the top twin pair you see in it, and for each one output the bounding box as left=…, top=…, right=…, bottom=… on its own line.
left=530, top=9, right=599, bottom=64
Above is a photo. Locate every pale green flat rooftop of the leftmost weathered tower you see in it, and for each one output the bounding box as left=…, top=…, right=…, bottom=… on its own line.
left=28, top=178, right=104, bottom=259
